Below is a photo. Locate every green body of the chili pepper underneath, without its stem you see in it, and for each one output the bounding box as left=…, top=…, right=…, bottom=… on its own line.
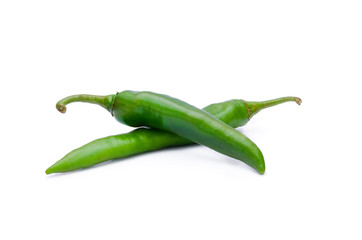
left=46, top=100, right=249, bottom=174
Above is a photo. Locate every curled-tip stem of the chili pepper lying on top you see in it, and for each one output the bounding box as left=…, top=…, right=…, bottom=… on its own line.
left=56, top=94, right=115, bottom=115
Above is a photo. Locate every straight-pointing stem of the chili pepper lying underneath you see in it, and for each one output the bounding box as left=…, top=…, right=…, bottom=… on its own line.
left=243, top=97, right=302, bottom=119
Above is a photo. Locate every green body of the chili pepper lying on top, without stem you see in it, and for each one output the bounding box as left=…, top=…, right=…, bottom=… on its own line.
left=111, top=91, right=265, bottom=174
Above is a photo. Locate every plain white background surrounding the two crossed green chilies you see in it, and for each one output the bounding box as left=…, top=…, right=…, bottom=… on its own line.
left=0, top=0, right=362, bottom=239
